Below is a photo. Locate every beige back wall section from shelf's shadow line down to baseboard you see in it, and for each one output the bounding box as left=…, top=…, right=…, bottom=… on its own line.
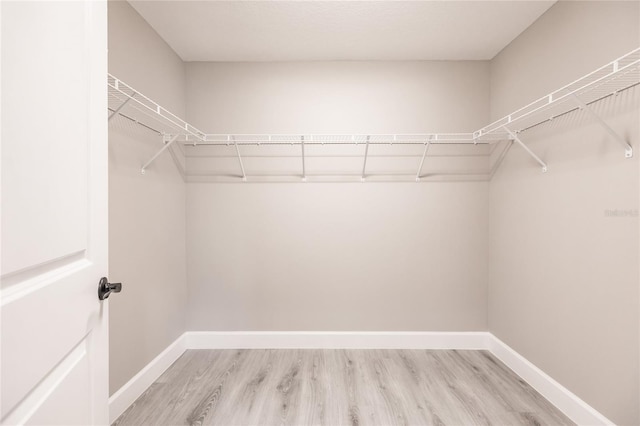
left=187, top=182, right=488, bottom=331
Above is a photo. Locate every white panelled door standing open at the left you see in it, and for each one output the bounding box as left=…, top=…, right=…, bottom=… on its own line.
left=0, top=1, right=108, bottom=425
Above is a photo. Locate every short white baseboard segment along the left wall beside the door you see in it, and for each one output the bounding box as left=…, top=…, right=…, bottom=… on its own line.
left=109, top=334, right=187, bottom=424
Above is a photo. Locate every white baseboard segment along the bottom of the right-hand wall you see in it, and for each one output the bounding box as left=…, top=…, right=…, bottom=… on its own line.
left=487, top=333, right=614, bottom=425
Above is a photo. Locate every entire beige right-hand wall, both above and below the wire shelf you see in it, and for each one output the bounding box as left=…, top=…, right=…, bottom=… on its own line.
left=489, top=2, right=640, bottom=424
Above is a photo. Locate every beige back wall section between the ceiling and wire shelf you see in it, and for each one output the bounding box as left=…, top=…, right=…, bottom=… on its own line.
left=186, top=61, right=489, bottom=133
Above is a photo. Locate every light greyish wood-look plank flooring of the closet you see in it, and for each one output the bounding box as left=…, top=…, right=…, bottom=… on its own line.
left=114, top=349, right=573, bottom=426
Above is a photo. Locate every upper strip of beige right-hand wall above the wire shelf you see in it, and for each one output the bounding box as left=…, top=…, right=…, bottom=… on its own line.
left=490, top=0, right=640, bottom=120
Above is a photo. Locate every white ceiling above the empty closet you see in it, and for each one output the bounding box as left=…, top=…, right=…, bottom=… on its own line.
left=129, top=0, right=555, bottom=61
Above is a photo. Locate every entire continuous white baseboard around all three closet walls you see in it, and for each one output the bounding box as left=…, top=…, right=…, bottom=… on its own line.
left=109, top=331, right=613, bottom=425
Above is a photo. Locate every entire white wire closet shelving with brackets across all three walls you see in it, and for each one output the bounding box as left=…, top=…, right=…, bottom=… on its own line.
left=108, top=48, right=640, bottom=181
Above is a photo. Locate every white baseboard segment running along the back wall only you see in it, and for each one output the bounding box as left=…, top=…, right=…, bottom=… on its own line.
left=185, top=331, right=487, bottom=349
